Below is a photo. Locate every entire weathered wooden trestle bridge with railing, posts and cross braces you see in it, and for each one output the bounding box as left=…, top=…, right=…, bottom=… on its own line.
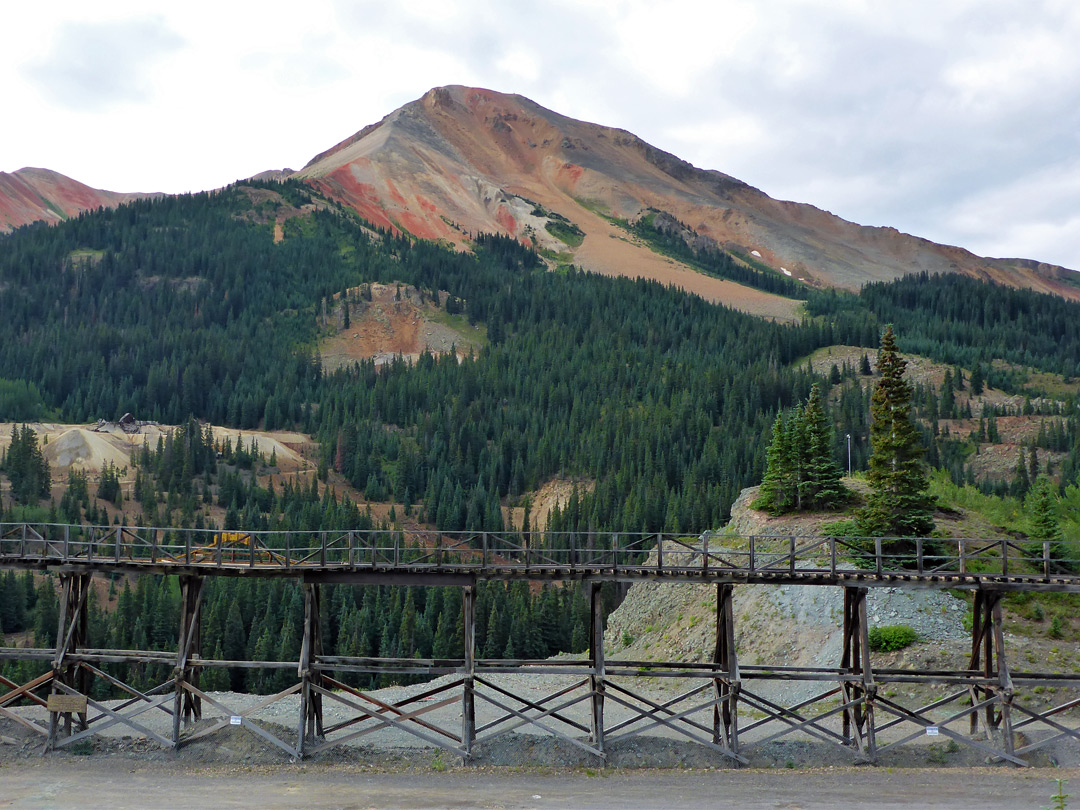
left=0, top=524, right=1080, bottom=765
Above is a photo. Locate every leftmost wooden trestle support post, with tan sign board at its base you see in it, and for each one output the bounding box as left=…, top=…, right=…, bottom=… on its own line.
left=45, top=572, right=91, bottom=751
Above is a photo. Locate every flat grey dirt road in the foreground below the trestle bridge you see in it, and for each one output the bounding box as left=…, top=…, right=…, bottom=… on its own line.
left=0, top=759, right=1067, bottom=810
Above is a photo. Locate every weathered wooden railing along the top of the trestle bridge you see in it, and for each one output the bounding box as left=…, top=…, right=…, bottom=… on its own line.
left=0, top=523, right=1080, bottom=588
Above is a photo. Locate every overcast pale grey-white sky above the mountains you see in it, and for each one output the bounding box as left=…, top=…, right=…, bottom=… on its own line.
left=0, top=0, right=1080, bottom=269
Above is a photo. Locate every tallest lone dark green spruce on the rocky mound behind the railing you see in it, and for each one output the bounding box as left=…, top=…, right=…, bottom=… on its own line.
left=856, top=325, right=934, bottom=537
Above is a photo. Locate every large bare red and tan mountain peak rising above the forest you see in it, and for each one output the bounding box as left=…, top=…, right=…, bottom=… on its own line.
left=294, top=86, right=1080, bottom=306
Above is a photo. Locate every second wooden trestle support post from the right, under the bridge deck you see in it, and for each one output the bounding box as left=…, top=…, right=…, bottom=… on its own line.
left=840, top=588, right=877, bottom=762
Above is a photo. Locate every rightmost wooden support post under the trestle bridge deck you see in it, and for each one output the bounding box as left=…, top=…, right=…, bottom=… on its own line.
left=968, top=589, right=1014, bottom=756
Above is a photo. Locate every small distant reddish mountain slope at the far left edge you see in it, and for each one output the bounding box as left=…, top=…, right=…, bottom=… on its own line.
left=0, top=168, right=149, bottom=233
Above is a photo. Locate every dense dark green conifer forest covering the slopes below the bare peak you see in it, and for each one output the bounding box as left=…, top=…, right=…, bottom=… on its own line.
left=0, top=181, right=1080, bottom=692
